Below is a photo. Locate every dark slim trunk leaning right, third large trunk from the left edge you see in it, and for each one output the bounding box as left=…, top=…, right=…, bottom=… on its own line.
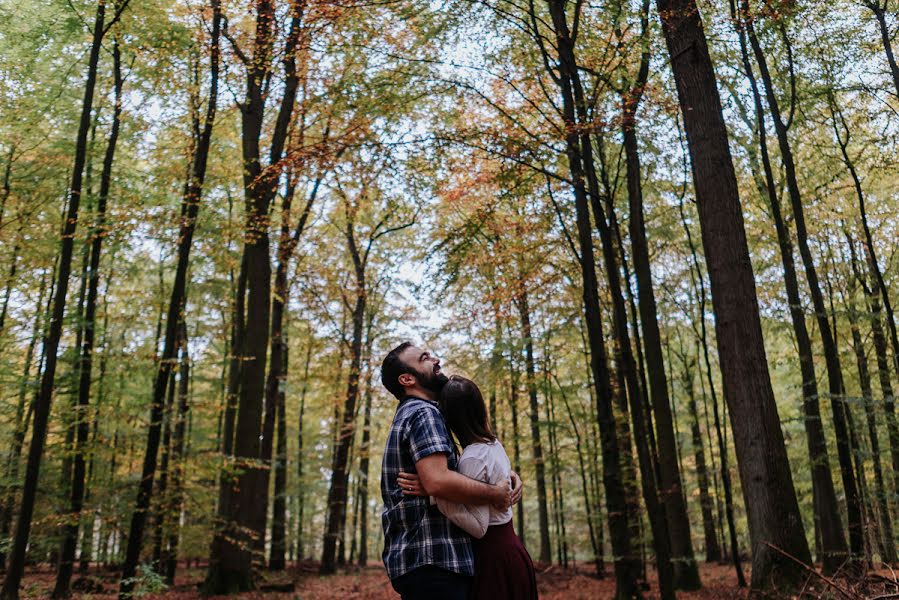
left=119, top=0, right=222, bottom=600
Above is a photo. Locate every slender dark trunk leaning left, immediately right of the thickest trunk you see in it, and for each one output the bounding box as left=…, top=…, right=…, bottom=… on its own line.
left=731, top=0, right=848, bottom=574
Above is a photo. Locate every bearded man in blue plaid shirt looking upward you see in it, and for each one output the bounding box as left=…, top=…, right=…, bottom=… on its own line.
left=381, top=342, right=521, bottom=600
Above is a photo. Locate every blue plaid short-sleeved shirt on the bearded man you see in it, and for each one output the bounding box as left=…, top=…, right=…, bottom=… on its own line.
left=381, top=397, right=474, bottom=579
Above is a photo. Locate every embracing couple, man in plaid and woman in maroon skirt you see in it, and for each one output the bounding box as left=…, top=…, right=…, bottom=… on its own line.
left=381, top=342, right=537, bottom=600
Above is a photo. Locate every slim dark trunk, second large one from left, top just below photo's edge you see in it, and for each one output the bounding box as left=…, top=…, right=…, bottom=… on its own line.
left=53, top=38, right=122, bottom=598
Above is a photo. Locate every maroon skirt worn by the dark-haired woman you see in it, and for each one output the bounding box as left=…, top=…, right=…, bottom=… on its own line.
left=469, top=520, right=537, bottom=600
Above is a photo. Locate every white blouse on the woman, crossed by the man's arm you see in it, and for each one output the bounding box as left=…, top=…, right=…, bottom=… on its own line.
left=437, top=440, right=512, bottom=538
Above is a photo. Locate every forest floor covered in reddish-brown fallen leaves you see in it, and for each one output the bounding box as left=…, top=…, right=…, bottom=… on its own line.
left=21, top=562, right=899, bottom=600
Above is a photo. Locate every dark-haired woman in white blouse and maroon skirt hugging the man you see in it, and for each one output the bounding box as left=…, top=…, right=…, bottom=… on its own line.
left=400, top=376, right=537, bottom=600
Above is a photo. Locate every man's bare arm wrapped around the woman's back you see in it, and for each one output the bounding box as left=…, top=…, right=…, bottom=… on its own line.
left=415, top=453, right=512, bottom=510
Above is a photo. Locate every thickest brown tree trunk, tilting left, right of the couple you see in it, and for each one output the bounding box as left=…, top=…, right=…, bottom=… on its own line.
left=657, top=0, right=811, bottom=591
